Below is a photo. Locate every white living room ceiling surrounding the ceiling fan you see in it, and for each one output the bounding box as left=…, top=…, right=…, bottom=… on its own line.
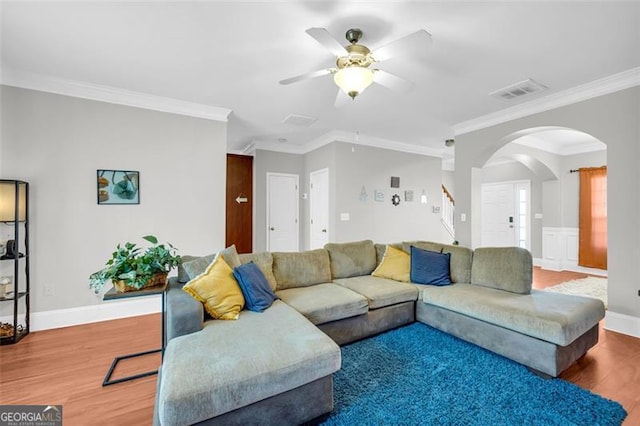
left=1, top=0, right=640, bottom=156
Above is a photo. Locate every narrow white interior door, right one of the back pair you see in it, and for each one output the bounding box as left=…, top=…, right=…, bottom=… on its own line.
left=309, top=169, right=329, bottom=250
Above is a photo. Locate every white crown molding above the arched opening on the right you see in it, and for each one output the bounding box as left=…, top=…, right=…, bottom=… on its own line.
left=452, top=67, right=640, bottom=135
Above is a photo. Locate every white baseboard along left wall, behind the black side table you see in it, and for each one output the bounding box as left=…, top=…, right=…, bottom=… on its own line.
left=0, top=295, right=162, bottom=331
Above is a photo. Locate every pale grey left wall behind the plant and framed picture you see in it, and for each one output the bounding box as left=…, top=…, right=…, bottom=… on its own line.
left=0, top=86, right=226, bottom=314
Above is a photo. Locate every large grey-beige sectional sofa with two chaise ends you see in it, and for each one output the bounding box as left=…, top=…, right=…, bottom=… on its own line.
left=154, top=241, right=604, bottom=426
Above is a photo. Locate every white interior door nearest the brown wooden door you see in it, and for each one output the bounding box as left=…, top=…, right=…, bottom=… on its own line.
left=267, top=173, right=299, bottom=251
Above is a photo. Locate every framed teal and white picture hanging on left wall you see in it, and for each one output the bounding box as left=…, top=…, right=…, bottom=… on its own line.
left=97, top=169, right=140, bottom=204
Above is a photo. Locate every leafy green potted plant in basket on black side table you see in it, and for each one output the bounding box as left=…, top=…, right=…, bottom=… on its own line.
left=89, top=235, right=180, bottom=293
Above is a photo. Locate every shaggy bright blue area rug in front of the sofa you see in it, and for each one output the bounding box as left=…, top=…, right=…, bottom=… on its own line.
left=323, top=323, right=626, bottom=426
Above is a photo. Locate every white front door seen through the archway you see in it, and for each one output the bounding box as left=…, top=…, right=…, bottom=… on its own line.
left=481, top=181, right=530, bottom=249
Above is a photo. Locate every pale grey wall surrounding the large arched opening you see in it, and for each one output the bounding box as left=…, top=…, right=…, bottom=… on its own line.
left=455, top=86, right=640, bottom=336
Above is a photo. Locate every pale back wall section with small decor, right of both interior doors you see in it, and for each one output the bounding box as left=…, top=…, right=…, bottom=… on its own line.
left=331, top=142, right=444, bottom=243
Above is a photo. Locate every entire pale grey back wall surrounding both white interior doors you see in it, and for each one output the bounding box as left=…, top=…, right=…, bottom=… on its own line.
left=254, top=142, right=451, bottom=251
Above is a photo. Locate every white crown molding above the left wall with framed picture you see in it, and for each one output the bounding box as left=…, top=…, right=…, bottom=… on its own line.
left=0, top=67, right=231, bottom=122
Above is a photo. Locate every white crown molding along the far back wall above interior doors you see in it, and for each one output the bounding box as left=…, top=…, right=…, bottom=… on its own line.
left=242, top=130, right=444, bottom=158
